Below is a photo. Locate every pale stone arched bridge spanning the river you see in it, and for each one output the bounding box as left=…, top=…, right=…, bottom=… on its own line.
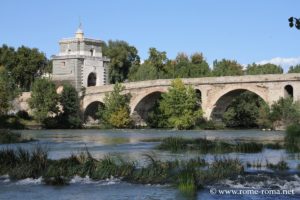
left=81, top=73, right=300, bottom=122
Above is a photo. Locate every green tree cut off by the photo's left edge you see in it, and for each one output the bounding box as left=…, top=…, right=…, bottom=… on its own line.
left=0, top=66, right=18, bottom=116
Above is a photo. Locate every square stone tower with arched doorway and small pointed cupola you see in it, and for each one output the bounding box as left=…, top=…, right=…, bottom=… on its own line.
left=52, top=25, right=109, bottom=91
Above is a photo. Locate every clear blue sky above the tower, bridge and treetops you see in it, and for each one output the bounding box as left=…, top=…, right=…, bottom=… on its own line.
left=0, top=0, right=300, bottom=70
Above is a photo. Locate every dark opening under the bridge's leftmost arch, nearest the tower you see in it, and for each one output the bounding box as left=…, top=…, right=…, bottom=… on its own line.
left=84, top=101, right=104, bottom=124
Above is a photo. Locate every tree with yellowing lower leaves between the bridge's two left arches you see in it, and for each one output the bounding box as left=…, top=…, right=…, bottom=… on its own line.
left=97, top=83, right=132, bottom=128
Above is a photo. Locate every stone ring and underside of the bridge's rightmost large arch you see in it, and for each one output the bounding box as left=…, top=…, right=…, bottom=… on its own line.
left=204, top=86, right=271, bottom=120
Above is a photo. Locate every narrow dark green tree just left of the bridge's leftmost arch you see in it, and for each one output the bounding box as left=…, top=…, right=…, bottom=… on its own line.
left=59, top=84, right=82, bottom=128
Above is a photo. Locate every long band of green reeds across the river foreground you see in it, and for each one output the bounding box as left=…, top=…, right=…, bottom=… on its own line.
left=0, top=146, right=250, bottom=195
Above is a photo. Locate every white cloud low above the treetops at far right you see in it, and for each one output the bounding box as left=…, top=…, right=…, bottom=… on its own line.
left=255, top=57, right=300, bottom=72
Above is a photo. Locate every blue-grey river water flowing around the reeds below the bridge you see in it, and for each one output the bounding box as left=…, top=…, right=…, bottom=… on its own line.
left=0, top=129, right=300, bottom=200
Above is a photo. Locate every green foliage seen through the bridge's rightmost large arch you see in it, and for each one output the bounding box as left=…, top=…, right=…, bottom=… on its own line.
left=223, top=91, right=265, bottom=128
